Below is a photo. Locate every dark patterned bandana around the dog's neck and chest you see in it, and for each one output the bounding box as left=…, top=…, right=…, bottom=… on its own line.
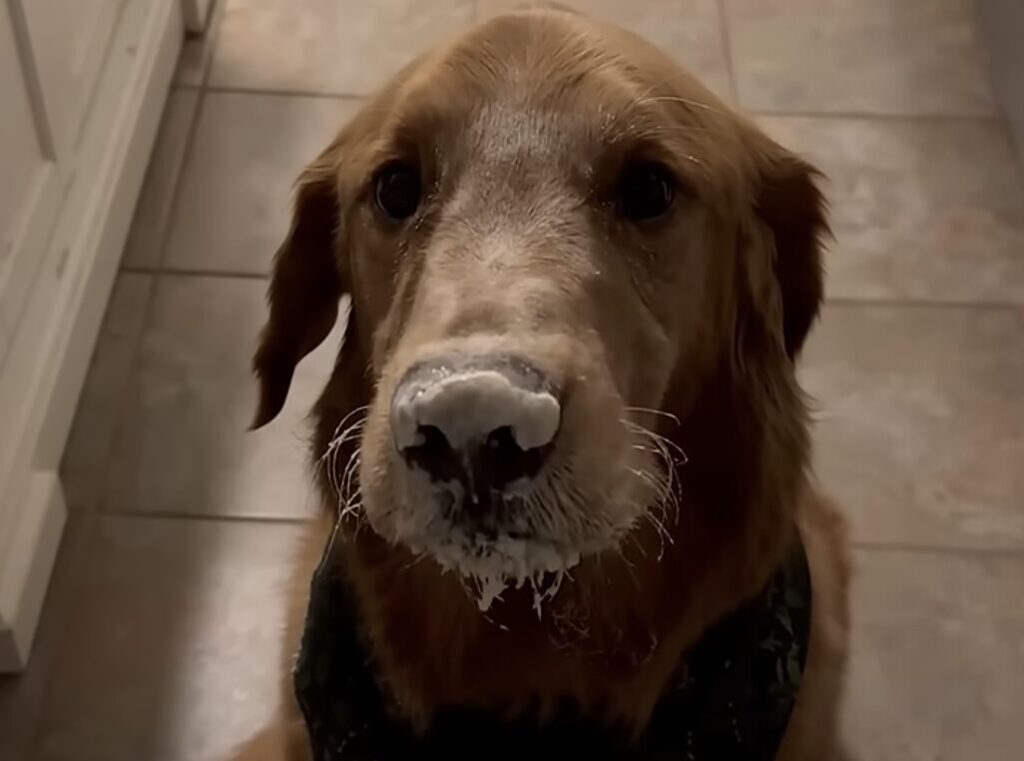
left=295, top=524, right=811, bottom=761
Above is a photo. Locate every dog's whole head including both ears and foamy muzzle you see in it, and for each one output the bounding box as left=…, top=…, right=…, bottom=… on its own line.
left=256, top=11, right=822, bottom=603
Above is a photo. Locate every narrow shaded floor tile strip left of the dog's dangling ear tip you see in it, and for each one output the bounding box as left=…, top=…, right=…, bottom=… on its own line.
left=60, top=272, right=153, bottom=510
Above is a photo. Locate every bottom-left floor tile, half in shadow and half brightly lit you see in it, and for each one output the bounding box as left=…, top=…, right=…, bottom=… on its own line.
left=25, top=516, right=299, bottom=761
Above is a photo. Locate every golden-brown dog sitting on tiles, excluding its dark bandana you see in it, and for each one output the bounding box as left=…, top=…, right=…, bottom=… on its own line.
left=234, top=6, right=849, bottom=761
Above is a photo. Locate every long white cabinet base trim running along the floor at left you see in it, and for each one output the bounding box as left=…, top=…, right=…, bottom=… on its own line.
left=0, top=0, right=184, bottom=673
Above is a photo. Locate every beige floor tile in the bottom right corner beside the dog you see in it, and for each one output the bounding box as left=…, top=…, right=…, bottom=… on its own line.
left=845, top=552, right=1024, bottom=761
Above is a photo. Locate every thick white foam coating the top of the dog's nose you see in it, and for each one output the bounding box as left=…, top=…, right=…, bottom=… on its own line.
left=391, top=370, right=561, bottom=450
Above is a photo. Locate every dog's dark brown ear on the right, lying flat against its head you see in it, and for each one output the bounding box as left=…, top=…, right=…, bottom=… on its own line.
left=754, top=135, right=829, bottom=360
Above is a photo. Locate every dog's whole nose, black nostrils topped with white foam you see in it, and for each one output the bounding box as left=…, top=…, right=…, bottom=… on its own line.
left=391, top=357, right=561, bottom=504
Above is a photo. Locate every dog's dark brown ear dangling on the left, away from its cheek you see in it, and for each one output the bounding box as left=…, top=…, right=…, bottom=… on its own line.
left=252, top=145, right=347, bottom=428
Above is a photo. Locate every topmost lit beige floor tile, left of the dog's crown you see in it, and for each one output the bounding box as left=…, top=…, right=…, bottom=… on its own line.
left=210, top=0, right=474, bottom=95
